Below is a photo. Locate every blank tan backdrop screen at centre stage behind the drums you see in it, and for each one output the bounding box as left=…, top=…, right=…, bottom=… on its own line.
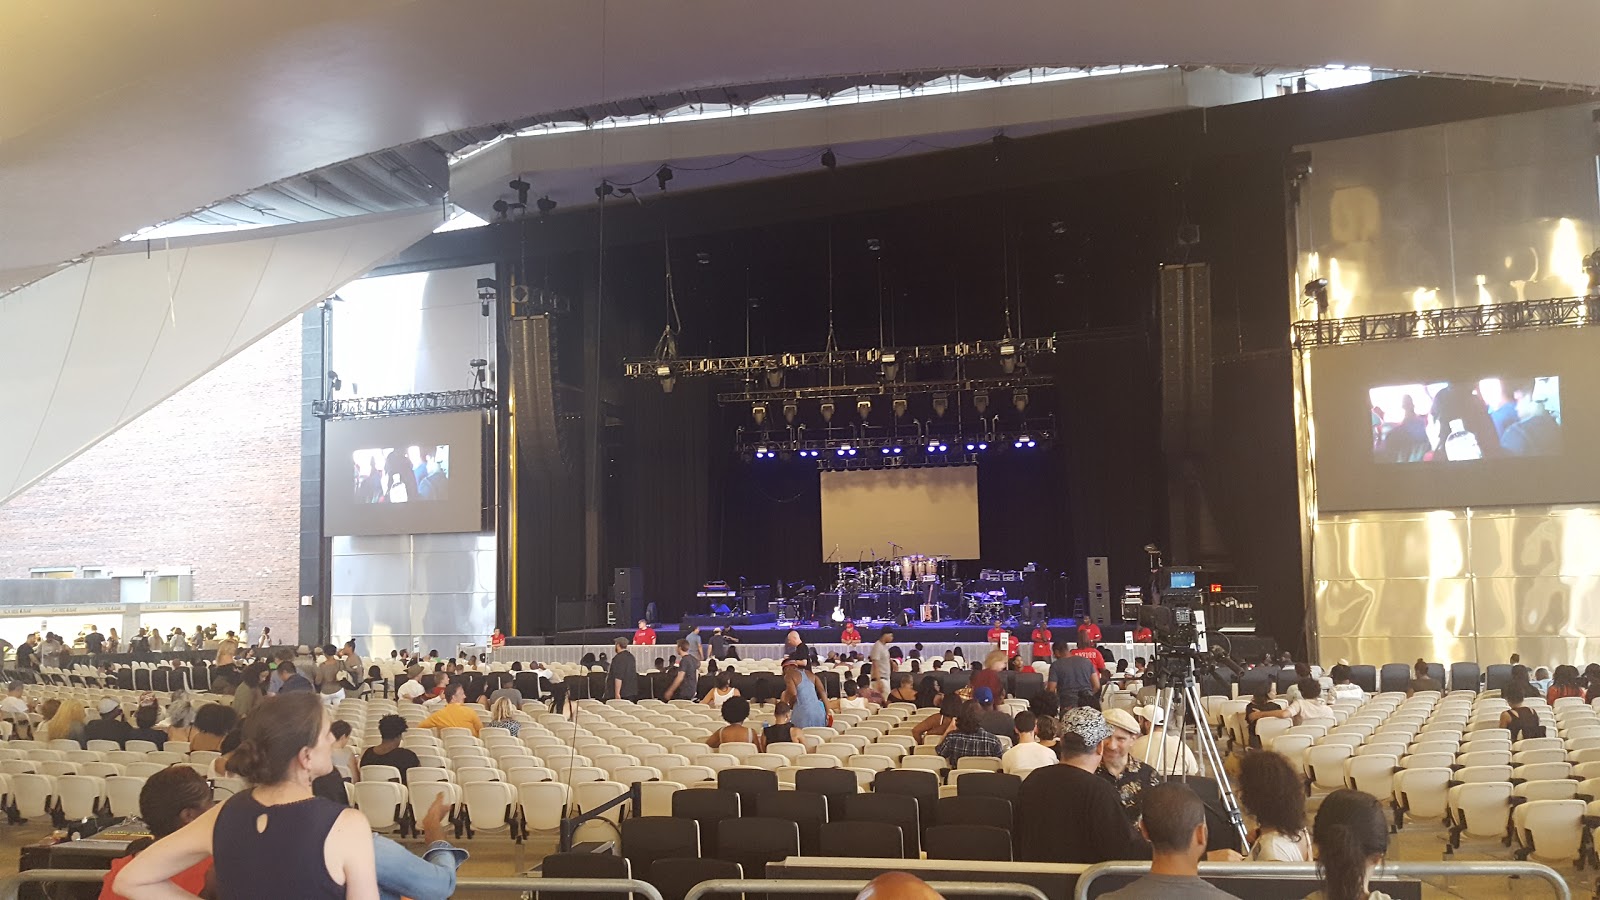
left=822, top=466, right=981, bottom=562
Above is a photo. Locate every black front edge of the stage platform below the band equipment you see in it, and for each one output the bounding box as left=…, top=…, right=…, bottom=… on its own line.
left=506, top=615, right=1131, bottom=647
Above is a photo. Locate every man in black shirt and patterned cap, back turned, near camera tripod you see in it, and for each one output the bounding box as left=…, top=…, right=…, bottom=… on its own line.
left=1016, top=706, right=1150, bottom=863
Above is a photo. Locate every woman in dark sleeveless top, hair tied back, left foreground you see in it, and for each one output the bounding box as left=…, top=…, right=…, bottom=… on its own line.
left=114, top=692, right=378, bottom=900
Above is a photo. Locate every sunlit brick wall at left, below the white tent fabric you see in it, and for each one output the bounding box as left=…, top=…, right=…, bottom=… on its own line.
left=0, top=319, right=301, bottom=641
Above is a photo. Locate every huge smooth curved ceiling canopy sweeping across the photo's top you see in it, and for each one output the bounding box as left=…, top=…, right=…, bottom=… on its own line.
left=0, top=0, right=1600, bottom=290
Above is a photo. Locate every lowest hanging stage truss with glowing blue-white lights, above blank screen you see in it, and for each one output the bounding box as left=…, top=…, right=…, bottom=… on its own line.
left=734, top=416, right=1058, bottom=469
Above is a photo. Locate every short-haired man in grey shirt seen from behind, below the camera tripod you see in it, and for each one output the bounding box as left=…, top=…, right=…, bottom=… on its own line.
left=1101, top=781, right=1234, bottom=900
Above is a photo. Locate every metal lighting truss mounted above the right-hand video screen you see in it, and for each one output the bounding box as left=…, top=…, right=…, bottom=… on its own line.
left=1293, top=296, right=1595, bottom=348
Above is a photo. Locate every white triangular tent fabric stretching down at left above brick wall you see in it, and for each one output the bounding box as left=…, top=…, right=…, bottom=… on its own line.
left=0, top=208, right=440, bottom=501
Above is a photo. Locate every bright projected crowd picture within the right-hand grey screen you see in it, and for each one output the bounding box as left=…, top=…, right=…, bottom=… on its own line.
left=1368, top=375, right=1562, bottom=463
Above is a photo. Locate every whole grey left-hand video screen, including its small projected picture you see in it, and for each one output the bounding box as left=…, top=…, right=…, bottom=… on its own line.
left=323, top=412, right=483, bottom=535
